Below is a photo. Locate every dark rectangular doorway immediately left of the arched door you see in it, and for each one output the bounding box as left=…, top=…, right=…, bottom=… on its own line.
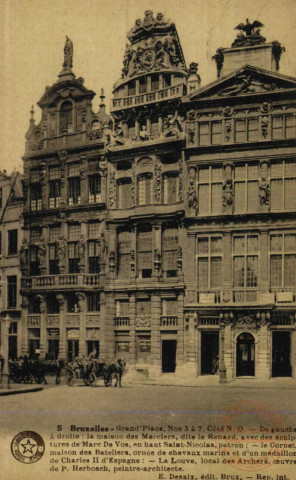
left=200, top=331, right=219, bottom=375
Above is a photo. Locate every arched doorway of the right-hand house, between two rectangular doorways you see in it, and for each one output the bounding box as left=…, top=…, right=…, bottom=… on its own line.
left=236, top=333, right=255, bottom=377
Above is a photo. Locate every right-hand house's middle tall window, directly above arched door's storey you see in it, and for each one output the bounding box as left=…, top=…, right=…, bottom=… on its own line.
left=233, top=235, right=258, bottom=288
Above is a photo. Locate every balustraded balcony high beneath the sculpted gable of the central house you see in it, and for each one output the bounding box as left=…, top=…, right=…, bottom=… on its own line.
left=112, top=83, right=185, bottom=112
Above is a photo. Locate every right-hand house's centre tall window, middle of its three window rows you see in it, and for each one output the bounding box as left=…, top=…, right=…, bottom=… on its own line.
left=234, top=164, right=259, bottom=212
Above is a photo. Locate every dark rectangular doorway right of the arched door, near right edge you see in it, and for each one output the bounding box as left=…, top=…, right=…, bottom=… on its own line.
left=272, top=332, right=292, bottom=377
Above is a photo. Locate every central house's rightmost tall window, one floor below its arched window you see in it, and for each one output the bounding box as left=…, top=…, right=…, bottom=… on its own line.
left=162, top=227, right=178, bottom=277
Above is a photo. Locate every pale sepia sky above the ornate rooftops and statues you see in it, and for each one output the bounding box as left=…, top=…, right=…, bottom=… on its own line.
left=0, top=0, right=296, bottom=173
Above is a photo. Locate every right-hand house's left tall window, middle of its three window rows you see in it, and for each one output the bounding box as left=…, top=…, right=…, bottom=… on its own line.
left=198, top=167, right=222, bottom=215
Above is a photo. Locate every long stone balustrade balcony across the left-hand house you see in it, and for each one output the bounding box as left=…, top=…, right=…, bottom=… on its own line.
left=22, top=273, right=100, bottom=290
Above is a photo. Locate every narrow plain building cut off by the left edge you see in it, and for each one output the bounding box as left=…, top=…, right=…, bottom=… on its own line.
left=0, top=171, right=23, bottom=358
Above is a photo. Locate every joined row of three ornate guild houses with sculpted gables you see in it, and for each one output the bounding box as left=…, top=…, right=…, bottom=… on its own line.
left=19, top=10, right=296, bottom=383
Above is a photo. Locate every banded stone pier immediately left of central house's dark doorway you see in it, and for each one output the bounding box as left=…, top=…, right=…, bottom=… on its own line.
left=149, top=295, right=161, bottom=377
